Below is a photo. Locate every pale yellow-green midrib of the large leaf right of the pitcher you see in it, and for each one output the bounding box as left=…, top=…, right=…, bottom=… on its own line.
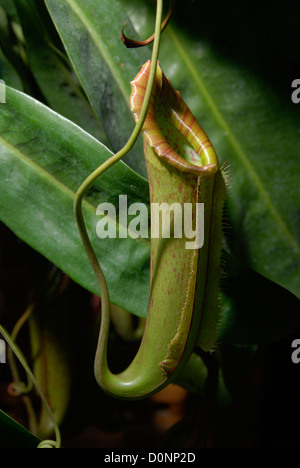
left=167, top=26, right=300, bottom=256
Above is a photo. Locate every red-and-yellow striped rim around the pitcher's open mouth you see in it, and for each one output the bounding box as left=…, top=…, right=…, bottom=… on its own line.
left=130, top=60, right=219, bottom=176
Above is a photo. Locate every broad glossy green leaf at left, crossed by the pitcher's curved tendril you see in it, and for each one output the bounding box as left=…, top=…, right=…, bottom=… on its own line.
left=0, top=88, right=150, bottom=316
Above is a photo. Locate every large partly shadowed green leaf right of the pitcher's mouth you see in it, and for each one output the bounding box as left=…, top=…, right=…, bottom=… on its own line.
left=121, top=0, right=300, bottom=297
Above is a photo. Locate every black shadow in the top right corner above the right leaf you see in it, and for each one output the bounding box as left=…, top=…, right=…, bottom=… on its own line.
left=172, top=0, right=300, bottom=102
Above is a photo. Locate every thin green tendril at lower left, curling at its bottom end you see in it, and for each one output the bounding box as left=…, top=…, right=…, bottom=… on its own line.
left=0, top=325, right=61, bottom=448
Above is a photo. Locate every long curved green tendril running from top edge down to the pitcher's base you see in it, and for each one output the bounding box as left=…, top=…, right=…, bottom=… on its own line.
left=74, top=0, right=163, bottom=370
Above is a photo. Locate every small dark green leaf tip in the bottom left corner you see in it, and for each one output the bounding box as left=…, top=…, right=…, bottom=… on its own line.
left=0, top=409, right=41, bottom=448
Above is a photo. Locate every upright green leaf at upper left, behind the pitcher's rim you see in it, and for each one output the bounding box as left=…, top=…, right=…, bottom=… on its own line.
left=46, top=0, right=154, bottom=177
